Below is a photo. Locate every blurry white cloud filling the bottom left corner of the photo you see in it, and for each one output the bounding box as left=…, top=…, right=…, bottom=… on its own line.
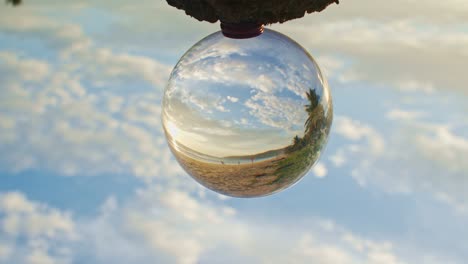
left=0, top=192, right=79, bottom=264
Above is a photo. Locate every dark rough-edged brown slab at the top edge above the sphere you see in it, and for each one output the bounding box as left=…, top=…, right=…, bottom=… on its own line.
left=167, top=0, right=338, bottom=24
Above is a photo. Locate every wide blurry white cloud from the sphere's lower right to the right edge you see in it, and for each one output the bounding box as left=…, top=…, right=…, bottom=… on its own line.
left=330, top=112, right=468, bottom=214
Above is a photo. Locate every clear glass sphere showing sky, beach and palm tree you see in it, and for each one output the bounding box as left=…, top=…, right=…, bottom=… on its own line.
left=162, top=29, right=333, bottom=197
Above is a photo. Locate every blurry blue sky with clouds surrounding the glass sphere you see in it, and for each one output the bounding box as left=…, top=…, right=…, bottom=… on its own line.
left=0, top=0, right=468, bottom=264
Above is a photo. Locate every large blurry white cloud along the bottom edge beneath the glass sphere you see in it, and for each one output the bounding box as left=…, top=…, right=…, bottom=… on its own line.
left=76, top=187, right=416, bottom=264
